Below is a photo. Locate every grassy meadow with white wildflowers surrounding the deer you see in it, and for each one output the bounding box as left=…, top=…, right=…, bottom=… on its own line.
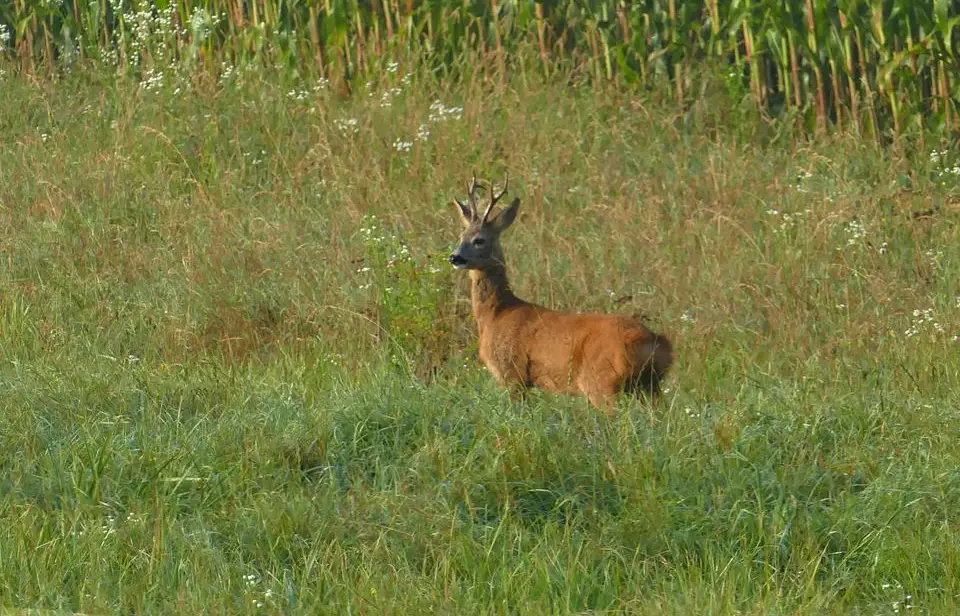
left=0, top=55, right=960, bottom=615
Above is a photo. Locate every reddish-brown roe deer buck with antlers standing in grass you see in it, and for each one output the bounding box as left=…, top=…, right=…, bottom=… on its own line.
left=449, top=176, right=673, bottom=414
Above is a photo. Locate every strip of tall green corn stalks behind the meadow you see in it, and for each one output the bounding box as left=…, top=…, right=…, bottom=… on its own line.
left=0, top=0, right=960, bottom=138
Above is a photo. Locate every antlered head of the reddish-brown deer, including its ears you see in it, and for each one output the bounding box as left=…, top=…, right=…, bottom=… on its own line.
left=450, top=175, right=520, bottom=269
